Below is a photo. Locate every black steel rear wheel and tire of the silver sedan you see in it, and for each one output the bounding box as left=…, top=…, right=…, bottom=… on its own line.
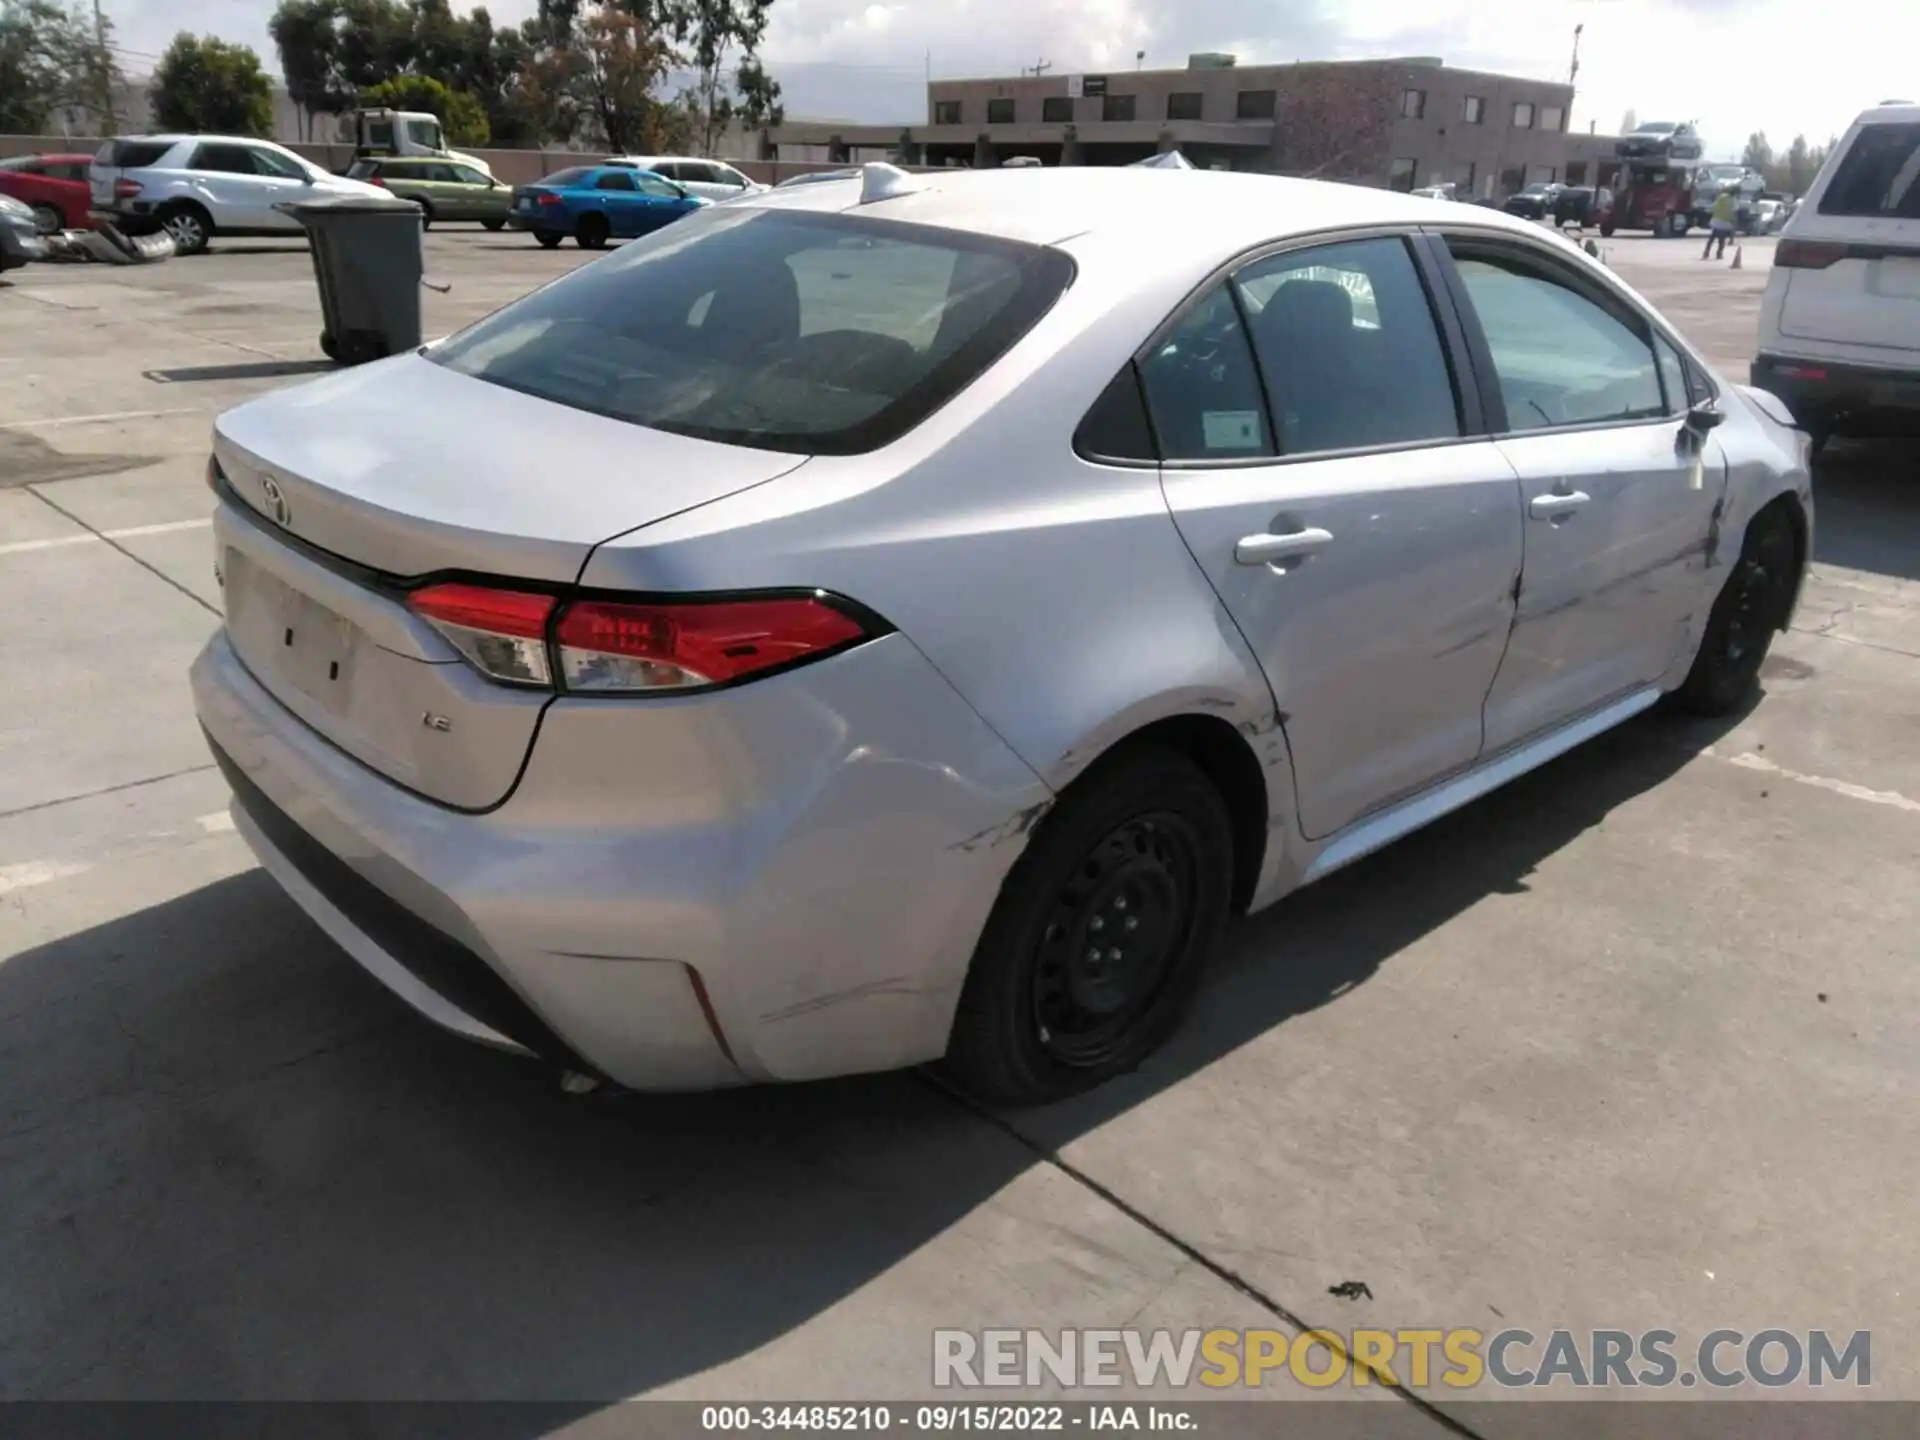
left=947, top=745, right=1233, bottom=1104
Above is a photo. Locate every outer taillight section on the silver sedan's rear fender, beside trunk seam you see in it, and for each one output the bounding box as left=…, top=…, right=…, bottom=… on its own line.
left=553, top=595, right=870, bottom=693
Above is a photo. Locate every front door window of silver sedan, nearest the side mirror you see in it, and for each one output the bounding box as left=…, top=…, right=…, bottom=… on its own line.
left=1453, top=242, right=1667, bottom=430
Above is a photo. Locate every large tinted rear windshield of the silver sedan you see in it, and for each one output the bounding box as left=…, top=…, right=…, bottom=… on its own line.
left=432, top=207, right=1073, bottom=455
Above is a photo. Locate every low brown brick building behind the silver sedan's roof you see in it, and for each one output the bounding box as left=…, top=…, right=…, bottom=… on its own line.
left=766, top=56, right=1613, bottom=198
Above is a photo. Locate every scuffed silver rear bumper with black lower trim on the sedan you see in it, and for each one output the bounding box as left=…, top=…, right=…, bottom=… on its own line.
left=192, top=632, right=1046, bottom=1091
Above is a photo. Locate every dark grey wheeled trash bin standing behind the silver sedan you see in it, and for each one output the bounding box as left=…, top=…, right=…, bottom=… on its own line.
left=278, top=196, right=426, bottom=365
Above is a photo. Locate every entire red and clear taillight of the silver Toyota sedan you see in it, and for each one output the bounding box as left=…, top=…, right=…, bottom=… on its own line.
left=407, top=584, right=879, bottom=695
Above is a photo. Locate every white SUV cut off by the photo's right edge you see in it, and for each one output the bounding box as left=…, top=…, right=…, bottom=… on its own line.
left=1753, top=104, right=1920, bottom=444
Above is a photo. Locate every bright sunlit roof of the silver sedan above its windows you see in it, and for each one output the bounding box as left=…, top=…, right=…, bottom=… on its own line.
left=730, top=165, right=1540, bottom=253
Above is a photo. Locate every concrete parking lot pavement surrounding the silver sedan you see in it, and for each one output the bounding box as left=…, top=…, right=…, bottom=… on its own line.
left=0, top=228, right=1920, bottom=1434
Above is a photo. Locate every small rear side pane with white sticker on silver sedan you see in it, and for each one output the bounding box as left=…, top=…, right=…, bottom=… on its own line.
left=1140, top=282, right=1275, bottom=461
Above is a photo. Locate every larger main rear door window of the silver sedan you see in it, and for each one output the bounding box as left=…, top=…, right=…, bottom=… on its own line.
left=1235, top=238, right=1461, bottom=455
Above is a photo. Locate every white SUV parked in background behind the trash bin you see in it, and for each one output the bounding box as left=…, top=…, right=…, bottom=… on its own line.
left=86, top=134, right=392, bottom=255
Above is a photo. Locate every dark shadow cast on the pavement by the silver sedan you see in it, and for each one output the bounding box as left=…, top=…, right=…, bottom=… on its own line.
left=0, top=702, right=1758, bottom=1434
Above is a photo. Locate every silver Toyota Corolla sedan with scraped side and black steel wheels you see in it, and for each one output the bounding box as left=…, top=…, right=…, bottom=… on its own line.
left=194, top=167, right=1812, bottom=1100
